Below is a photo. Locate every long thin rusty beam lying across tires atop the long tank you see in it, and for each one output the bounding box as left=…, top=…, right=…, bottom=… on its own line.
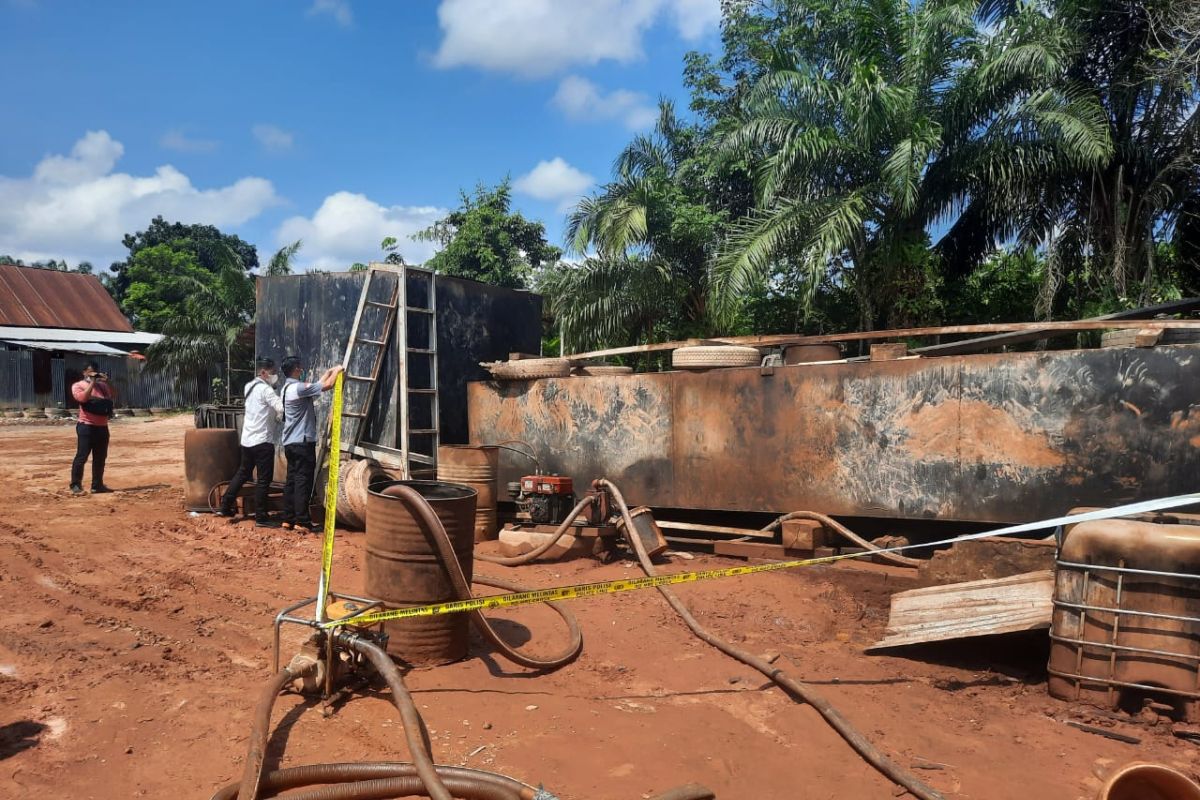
left=564, top=319, right=1200, bottom=361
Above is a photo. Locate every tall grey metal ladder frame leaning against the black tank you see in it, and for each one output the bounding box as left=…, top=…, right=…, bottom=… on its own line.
left=317, top=264, right=440, bottom=480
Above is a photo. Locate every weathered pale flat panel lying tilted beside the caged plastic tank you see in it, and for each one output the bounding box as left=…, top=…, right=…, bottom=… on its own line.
left=866, top=570, right=1054, bottom=652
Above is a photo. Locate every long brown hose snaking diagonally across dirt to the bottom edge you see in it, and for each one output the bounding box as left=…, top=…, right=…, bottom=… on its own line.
left=594, top=479, right=944, bottom=800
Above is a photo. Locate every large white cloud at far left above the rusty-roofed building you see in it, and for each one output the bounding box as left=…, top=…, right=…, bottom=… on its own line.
left=0, top=131, right=280, bottom=264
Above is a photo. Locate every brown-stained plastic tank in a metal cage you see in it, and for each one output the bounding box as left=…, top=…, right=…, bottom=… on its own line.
left=1048, top=519, right=1200, bottom=722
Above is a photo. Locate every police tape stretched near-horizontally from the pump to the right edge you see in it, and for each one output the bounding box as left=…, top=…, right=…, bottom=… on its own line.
left=322, top=493, right=1200, bottom=628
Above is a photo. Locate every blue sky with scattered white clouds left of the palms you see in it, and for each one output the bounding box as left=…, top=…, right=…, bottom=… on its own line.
left=0, top=0, right=719, bottom=269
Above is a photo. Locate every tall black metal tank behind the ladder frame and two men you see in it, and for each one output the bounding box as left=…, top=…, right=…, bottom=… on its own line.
left=254, top=272, right=541, bottom=446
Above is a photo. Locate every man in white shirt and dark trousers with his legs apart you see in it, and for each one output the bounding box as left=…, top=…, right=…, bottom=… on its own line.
left=217, top=359, right=283, bottom=528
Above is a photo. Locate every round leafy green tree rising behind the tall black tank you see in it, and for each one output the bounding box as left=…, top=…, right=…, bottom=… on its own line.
left=413, top=179, right=562, bottom=289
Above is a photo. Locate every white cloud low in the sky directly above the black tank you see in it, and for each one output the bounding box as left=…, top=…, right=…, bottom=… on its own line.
left=275, top=192, right=448, bottom=270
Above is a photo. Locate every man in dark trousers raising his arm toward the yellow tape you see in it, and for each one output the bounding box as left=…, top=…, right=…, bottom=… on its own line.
left=280, top=355, right=342, bottom=530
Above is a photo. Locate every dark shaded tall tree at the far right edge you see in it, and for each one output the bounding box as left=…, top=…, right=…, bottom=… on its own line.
left=998, top=0, right=1200, bottom=315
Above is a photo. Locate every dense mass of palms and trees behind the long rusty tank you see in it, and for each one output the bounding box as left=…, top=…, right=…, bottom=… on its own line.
left=549, top=0, right=1200, bottom=349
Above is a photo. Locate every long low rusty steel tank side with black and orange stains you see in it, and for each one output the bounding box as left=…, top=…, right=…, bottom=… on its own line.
left=470, top=347, right=1200, bottom=523
